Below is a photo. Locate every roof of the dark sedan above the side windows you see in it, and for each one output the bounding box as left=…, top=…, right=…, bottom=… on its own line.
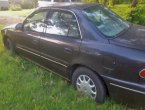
left=39, top=3, right=97, bottom=10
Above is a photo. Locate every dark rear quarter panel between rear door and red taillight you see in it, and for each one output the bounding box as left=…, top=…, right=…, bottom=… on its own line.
left=73, top=40, right=145, bottom=82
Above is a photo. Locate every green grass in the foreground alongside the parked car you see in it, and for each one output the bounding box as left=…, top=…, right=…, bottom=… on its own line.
left=0, top=25, right=129, bottom=110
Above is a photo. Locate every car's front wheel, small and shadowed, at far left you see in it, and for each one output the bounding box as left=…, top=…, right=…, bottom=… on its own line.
left=5, top=38, right=15, bottom=54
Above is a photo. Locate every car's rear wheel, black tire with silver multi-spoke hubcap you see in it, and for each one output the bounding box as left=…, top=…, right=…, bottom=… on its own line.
left=72, top=67, right=107, bottom=103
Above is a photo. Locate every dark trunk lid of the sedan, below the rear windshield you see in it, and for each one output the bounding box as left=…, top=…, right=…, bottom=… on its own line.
left=110, top=24, right=145, bottom=50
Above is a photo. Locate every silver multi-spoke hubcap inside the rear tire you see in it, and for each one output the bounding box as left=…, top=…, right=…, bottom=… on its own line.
left=76, top=75, right=97, bottom=100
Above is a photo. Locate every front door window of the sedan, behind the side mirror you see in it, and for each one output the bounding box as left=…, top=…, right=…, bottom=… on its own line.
left=24, top=10, right=47, bottom=32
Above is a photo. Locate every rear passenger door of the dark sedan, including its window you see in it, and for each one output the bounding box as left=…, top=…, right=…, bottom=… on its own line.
left=40, top=9, right=81, bottom=75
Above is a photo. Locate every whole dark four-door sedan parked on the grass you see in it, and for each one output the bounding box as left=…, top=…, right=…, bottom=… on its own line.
left=1, top=3, right=145, bottom=105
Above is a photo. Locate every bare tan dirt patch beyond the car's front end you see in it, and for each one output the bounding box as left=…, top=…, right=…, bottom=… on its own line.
left=0, top=15, right=24, bottom=26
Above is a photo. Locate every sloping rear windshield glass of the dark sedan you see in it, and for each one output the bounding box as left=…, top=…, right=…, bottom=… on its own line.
left=83, top=5, right=129, bottom=38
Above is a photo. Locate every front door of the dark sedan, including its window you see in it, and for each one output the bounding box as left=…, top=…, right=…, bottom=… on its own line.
left=16, top=10, right=47, bottom=61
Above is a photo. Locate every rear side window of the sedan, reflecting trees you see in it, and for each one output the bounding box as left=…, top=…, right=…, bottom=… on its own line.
left=46, top=11, right=79, bottom=37
